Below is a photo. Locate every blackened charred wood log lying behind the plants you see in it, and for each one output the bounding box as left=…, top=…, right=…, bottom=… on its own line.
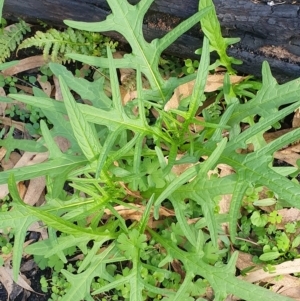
left=3, top=0, right=300, bottom=82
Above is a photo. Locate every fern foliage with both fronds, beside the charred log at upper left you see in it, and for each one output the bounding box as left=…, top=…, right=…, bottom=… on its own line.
left=0, top=11, right=118, bottom=63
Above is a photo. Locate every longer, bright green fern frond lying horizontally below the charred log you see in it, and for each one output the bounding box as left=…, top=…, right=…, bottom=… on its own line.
left=18, top=27, right=116, bottom=63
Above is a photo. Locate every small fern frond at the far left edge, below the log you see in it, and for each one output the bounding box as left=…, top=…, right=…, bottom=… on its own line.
left=0, top=20, right=30, bottom=63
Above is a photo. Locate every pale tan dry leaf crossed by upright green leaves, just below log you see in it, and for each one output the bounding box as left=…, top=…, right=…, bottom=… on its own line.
left=164, top=74, right=244, bottom=111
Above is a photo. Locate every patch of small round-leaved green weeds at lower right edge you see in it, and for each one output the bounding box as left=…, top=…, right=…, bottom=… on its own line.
left=235, top=187, right=300, bottom=269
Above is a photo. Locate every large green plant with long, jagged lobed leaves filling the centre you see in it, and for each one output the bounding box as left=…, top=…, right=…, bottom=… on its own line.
left=0, top=0, right=300, bottom=301
